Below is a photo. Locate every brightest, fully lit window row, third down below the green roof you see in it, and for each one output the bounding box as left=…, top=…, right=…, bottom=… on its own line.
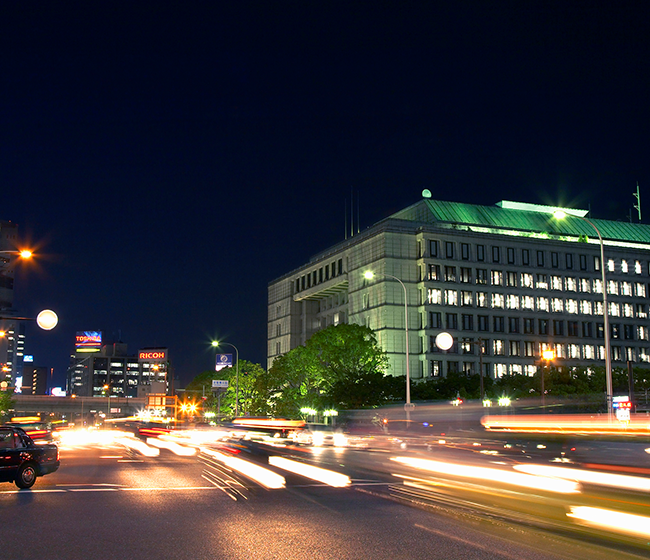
left=425, top=288, right=648, bottom=319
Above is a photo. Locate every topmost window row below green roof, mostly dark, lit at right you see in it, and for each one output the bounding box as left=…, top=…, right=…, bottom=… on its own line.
left=421, top=239, right=643, bottom=274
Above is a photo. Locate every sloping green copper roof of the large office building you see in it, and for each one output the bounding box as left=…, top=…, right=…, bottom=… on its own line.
left=391, top=199, right=650, bottom=243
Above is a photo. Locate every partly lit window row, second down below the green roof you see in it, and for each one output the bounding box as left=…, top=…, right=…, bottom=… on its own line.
left=421, top=264, right=647, bottom=297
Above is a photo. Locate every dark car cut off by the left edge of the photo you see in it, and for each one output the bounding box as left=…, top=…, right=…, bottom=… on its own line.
left=0, top=426, right=60, bottom=488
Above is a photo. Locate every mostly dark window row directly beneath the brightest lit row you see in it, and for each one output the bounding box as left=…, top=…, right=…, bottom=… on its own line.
left=428, top=311, right=650, bottom=340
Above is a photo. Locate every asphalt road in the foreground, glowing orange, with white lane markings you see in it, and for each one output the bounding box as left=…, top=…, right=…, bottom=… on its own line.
left=0, top=438, right=644, bottom=560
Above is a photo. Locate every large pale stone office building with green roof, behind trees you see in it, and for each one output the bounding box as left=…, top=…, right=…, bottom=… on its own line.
left=268, top=196, right=650, bottom=379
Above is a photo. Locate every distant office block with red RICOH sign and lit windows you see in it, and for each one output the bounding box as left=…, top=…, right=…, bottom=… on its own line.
left=67, top=337, right=169, bottom=397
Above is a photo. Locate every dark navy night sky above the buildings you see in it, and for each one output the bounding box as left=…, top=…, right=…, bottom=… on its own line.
left=0, top=0, right=650, bottom=385
